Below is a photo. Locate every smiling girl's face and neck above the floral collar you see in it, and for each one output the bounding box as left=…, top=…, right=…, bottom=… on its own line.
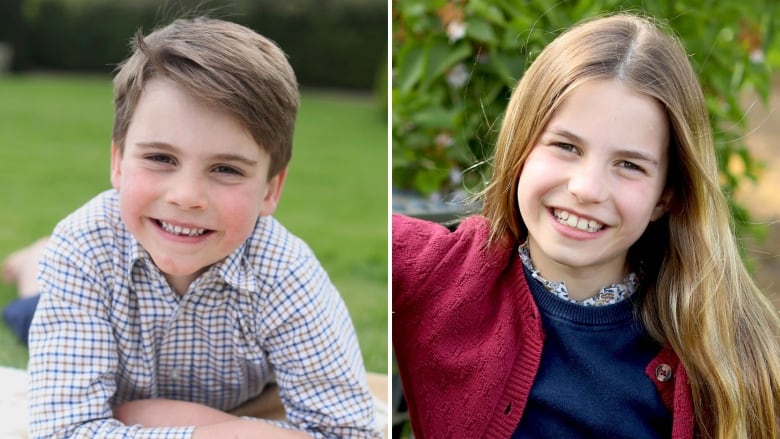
left=517, top=80, right=671, bottom=293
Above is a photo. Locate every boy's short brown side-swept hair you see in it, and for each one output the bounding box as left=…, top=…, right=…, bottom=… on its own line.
left=112, top=17, right=299, bottom=178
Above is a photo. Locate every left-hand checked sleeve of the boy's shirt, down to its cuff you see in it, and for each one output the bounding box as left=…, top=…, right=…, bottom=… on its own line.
left=28, top=232, right=194, bottom=439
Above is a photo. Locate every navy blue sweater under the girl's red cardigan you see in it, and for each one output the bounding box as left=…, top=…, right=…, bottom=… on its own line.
left=512, top=269, right=671, bottom=439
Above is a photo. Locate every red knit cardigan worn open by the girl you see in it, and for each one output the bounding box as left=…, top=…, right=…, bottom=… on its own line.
left=392, top=215, right=695, bottom=439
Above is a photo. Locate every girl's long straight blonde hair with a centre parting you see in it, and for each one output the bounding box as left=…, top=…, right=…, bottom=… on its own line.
left=481, top=14, right=780, bottom=439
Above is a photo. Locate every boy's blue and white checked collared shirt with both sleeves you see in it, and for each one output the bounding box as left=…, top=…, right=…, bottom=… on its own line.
left=29, top=190, right=379, bottom=439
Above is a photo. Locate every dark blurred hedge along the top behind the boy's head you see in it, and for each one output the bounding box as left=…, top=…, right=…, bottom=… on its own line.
left=0, top=0, right=387, bottom=90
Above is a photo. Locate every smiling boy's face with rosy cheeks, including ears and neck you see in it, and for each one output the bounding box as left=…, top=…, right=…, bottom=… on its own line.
left=111, top=78, right=286, bottom=294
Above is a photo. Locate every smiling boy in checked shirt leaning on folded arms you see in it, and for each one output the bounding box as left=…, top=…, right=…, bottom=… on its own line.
left=29, top=18, right=378, bottom=438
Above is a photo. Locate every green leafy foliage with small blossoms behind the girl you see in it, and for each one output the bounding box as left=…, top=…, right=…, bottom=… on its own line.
left=392, top=0, right=780, bottom=237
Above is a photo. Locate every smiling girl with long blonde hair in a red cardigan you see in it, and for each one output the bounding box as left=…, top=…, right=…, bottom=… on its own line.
left=393, top=14, right=780, bottom=439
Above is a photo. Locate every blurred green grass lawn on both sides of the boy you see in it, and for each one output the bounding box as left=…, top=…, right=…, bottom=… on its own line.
left=0, top=76, right=388, bottom=372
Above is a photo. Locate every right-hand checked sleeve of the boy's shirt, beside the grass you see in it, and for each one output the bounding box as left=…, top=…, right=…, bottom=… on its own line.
left=264, top=255, right=382, bottom=438
